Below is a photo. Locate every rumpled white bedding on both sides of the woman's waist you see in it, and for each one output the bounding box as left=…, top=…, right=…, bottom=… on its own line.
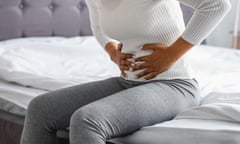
left=0, top=36, right=240, bottom=115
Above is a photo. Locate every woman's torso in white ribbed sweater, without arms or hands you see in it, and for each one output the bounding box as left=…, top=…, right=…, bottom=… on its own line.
left=98, top=0, right=191, bottom=81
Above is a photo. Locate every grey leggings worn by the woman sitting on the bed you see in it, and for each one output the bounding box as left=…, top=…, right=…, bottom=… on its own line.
left=21, top=77, right=199, bottom=144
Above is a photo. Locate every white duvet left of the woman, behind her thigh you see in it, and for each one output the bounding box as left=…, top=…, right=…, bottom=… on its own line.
left=0, top=36, right=120, bottom=90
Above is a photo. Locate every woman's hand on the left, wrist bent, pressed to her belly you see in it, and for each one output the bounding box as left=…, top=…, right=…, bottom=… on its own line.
left=105, top=42, right=134, bottom=77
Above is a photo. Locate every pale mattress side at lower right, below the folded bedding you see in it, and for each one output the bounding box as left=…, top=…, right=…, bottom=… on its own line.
left=109, top=119, right=240, bottom=144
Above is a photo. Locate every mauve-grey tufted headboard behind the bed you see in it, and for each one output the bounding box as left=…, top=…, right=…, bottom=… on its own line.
left=0, top=0, right=192, bottom=40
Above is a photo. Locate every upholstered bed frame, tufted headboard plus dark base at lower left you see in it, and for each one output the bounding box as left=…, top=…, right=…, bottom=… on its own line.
left=0, top=0, right=195, bottom=144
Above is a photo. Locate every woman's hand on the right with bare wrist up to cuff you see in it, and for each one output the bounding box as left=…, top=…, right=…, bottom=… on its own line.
left=130, top=37, right=194, bottom=80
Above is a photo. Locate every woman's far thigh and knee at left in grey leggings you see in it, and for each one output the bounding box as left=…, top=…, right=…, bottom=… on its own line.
left=26, top=77, right=125, bottom=129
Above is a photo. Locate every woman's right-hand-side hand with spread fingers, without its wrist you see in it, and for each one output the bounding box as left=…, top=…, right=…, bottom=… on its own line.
left=130, top=43, right=178, bottom=80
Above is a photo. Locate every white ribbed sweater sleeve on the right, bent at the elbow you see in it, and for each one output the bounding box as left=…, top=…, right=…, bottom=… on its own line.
left=178, top=0, right=231, bottom=45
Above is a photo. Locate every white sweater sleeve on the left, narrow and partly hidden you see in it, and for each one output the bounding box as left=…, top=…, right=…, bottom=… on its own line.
left=86, top=0, right=118, bottom=48
